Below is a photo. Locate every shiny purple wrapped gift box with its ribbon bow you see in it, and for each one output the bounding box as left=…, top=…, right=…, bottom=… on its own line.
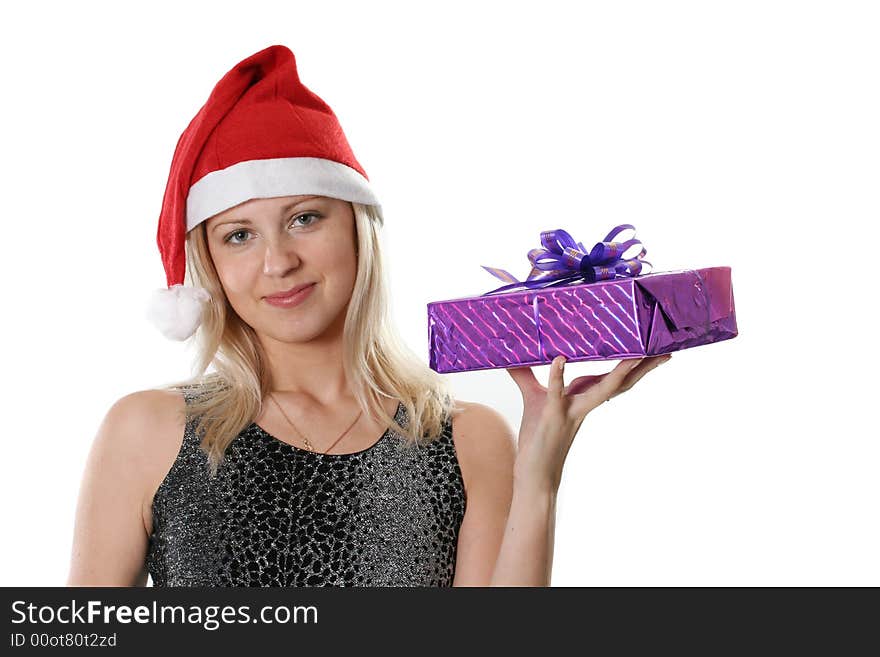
left=428, top=224, right=737, bottom=373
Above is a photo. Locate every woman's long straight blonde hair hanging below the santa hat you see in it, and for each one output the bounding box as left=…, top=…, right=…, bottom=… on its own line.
left=160, top=203, right=461, bottom=477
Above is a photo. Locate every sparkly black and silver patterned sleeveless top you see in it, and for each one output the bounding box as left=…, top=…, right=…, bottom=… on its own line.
left=147, top=389, right=466, bottom=587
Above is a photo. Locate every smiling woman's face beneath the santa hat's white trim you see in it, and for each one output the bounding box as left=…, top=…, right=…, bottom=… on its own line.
left=205, top=195, right=357, bottom=342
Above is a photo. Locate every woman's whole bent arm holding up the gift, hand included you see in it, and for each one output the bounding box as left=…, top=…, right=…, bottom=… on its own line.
left=453, top=356, right=669, bottom=586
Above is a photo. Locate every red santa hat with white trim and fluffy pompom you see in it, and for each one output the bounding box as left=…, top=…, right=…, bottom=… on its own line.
left=147, top=45, right=381, bottom=340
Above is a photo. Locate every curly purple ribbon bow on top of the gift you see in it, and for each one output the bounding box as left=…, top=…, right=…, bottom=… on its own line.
left=480, top=224, right=654, bottom=296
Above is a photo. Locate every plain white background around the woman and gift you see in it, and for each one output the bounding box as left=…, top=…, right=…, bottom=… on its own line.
left=0, top=0, right=880, bottom=586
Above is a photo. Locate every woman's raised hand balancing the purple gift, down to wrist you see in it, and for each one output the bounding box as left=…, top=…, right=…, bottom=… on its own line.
left=507, top=354, right=672, bottom=493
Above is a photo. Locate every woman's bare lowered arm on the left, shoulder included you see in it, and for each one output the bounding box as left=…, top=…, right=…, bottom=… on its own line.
left=67, top=391, right=176, bottom=586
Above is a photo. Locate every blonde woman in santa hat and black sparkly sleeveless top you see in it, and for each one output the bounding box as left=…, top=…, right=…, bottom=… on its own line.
left=68, top=46, right=661, bottom=586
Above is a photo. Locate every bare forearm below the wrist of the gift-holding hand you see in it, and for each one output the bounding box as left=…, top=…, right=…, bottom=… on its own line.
left=490, top=482, right=556, bottom=586
